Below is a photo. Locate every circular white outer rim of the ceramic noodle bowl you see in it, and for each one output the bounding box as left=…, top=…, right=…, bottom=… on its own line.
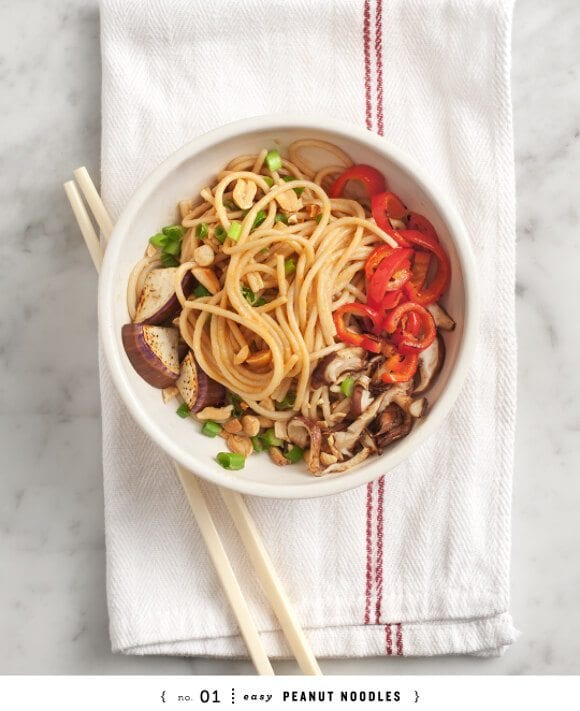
left=98, top=114, right=479, bottom=499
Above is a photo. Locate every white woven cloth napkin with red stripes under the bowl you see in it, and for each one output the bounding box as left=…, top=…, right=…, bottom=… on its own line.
left=101, top=0, right=516, bottom=657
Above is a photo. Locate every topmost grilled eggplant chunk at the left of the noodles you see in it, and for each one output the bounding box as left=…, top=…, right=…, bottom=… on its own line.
left=134, top=267, right=194, bottom=325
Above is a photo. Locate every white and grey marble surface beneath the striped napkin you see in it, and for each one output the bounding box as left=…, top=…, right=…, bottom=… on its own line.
left=0, top=0, right=580, bottom=674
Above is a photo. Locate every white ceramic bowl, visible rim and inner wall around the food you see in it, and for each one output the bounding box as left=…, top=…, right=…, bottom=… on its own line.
left=99, top=116, right=478, bottom=498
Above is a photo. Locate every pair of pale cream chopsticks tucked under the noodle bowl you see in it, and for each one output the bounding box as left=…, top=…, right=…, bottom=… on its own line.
left=64, top=167, right=321, bottom=675
